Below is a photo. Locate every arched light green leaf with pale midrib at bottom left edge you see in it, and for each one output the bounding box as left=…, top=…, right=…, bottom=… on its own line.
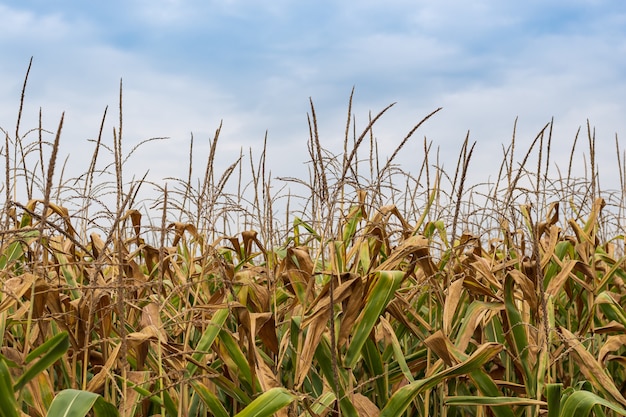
left=46, top=389, right=119, bottom=417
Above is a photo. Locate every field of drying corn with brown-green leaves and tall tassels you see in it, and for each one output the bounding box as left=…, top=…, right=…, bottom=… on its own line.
left=0, top=63, right=626, bottom=417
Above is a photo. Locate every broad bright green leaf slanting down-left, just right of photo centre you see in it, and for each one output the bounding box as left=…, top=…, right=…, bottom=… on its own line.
left=344, top=271, right=404, bottom=368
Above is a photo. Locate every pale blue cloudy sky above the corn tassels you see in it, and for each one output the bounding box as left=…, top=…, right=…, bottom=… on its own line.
left=0, top=0, right=626, bottom=213
